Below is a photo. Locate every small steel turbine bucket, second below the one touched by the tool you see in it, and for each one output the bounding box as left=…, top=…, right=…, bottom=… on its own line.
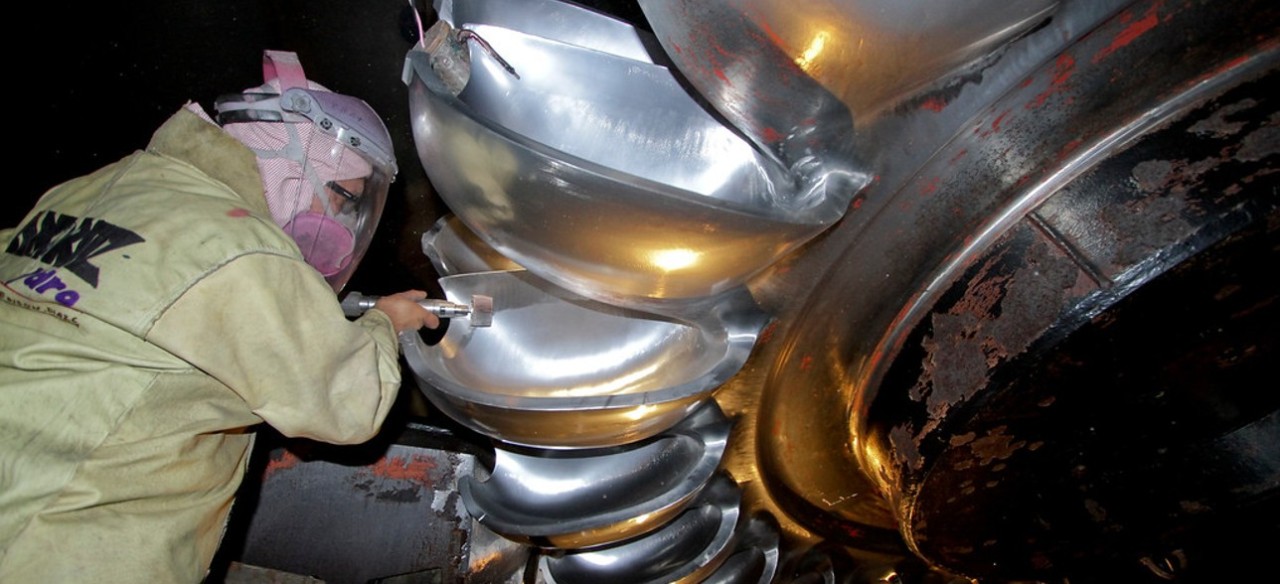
left=539, top=475, right=741, bottom=584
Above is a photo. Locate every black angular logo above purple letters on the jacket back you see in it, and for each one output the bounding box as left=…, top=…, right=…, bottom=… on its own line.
left=5, top=211, right=146, bottom=288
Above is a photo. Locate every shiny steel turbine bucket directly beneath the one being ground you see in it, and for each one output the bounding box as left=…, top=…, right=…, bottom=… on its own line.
left=458, top=401, right=732, bottom=549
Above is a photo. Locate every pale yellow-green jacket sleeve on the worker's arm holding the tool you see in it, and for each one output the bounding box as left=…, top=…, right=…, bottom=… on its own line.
left=147, top=254, right=401, bottom=444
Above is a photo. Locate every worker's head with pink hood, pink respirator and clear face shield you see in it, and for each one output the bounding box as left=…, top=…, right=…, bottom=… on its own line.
left=215, top=52, right=397, bottom=292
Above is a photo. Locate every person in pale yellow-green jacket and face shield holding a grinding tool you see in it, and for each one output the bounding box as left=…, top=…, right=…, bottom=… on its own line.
left=0, top=51, right=439, bottom=584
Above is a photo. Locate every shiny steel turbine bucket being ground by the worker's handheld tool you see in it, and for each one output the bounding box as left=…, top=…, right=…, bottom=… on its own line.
left=401, top=270, right=768, bottom=448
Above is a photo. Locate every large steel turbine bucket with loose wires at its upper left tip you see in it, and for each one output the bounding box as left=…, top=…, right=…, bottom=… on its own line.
left=403, top=10, right=867, bottom=305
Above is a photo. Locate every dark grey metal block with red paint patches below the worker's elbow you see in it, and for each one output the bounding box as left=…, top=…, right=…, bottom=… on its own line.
left=220, top=423, right=530, bottom=584
